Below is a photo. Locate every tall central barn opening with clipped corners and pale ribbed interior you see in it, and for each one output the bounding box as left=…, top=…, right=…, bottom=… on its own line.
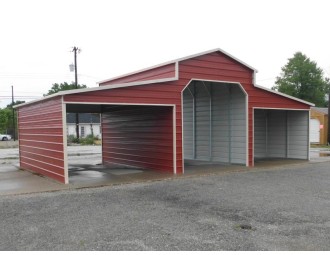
left=182, top=80, right=248, bottom=170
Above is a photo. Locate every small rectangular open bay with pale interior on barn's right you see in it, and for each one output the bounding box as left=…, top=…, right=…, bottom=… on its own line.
left=254, top=109, right=309, bottom=163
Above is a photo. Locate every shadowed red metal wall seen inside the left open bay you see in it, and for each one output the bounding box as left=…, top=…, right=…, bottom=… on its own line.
left=102, top=106, right=173, bottom=173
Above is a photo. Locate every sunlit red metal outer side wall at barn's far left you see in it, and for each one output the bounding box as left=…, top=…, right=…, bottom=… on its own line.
left=18, top=97, right=65, bottom=183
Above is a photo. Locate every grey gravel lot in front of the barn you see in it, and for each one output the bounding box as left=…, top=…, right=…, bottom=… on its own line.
left=0, top=162, right=330, bottom=250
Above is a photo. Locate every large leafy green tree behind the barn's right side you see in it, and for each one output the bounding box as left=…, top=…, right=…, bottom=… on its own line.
left=272, top=52, right=330, bottom=107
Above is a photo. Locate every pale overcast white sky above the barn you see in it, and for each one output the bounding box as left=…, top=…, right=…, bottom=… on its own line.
left=0, top=0, right=330, bottom=108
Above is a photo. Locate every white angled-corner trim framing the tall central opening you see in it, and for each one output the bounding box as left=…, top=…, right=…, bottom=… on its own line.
left=181, top=78, right=249, bottom=166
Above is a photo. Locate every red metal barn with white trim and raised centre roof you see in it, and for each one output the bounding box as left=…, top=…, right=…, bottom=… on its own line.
left=17, top=49, right=312, bottom=183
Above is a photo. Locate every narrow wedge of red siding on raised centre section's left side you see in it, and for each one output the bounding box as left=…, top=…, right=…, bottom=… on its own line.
left=100, top=64, right=175, bottom=86
